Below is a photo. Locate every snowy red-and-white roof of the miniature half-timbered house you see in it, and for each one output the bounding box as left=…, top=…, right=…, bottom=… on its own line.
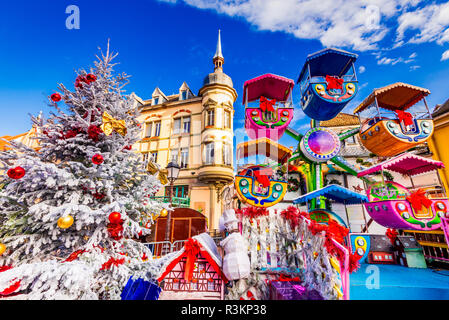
left=158, top=233, right=228, bottom=282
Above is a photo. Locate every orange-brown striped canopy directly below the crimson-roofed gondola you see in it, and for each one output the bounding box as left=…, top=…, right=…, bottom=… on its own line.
left=236, top=138, right=292, bottom=163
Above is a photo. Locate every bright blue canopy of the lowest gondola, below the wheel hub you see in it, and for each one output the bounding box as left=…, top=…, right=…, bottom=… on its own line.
left=293, top=184, right=368, bottom=204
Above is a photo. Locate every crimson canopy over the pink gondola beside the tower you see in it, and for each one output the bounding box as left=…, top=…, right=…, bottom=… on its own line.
left=243, top=73, right=295, bottom=104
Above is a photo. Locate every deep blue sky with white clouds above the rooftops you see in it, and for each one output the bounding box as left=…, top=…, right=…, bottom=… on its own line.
left=0, top=0, right=449, bottom=154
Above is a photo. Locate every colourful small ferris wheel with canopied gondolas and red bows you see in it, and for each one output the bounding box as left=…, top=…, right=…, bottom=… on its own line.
left=229, top=48, right=449, bottom=300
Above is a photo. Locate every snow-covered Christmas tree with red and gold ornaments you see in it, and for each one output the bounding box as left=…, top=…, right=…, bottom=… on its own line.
left=0, top=45, right=169, bottom=299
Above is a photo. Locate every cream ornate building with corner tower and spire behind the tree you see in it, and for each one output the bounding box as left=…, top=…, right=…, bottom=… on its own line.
left=133, top=33, right=237, bottom=230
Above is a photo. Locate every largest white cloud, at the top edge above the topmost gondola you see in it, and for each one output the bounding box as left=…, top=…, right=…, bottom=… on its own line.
left=180, top=0, right=417, bottom=51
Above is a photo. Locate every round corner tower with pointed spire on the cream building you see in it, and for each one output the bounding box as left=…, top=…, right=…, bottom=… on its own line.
left=198, top=30, right=237, bottom=230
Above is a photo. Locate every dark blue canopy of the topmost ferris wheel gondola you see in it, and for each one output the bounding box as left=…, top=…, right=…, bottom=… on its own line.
left=297, top=48, right=358, bottom=83
